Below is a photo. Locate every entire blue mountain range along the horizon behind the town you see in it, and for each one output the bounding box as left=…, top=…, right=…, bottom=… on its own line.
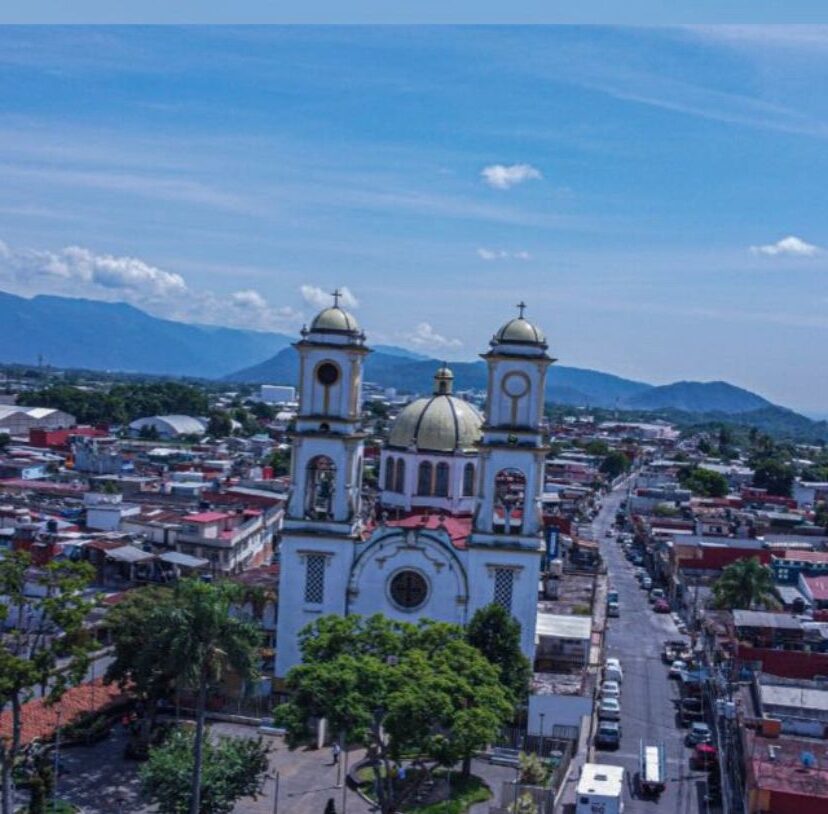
left=0, top=292, right=807, bottom=420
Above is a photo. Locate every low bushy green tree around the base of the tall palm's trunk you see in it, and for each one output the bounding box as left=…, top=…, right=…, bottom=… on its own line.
left=141, top=729, right=268, bottom=814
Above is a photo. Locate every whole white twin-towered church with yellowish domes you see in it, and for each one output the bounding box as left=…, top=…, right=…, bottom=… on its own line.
left=276, top=297, right=554, bottom=676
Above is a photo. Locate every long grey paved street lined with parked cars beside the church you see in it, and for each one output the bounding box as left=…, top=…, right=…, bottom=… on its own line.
left=593, top=486, right=708, bottom=814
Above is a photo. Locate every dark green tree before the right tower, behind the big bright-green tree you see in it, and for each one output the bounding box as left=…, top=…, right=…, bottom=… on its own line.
left=466, top=603, right=532, bottom=703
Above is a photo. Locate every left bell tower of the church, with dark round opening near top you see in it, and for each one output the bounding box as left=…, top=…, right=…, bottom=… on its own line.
left=275, top=290, right=369, bottom=676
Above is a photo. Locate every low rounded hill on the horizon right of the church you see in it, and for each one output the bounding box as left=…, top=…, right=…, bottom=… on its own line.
left=621, top=382, right=774, bottom=414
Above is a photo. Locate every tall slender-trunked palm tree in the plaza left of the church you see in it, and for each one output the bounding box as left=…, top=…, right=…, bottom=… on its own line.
left=167, top=579, right=260, bottom=814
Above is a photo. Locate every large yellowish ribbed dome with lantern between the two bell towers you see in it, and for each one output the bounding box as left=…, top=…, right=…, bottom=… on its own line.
left=388, top=367, right=483, bottom=452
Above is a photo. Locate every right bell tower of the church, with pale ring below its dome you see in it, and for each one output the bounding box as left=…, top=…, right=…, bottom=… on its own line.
left=469, top=302, right=555, bottom=661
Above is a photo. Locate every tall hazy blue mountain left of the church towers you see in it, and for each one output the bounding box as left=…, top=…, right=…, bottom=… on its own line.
left=0, top=292, right=291, bottom=378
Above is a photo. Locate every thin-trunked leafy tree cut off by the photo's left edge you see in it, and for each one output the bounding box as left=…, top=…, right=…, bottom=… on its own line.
left=0, top=552, right=95, bottom=814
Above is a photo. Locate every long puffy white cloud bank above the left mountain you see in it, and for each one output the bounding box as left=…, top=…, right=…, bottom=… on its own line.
left=0, top=243, right=187, bottom=297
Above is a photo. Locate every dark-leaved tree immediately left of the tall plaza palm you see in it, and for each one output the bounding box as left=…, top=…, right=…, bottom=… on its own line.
left=105, top=587, right=176, bottom=754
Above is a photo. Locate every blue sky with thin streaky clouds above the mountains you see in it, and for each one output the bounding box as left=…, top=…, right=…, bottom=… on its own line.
left=0, top=26, right=828, bottom=413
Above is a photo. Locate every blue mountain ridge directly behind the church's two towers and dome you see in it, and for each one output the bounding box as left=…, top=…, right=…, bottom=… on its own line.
left=225, top=348, right=651, bottom=407
